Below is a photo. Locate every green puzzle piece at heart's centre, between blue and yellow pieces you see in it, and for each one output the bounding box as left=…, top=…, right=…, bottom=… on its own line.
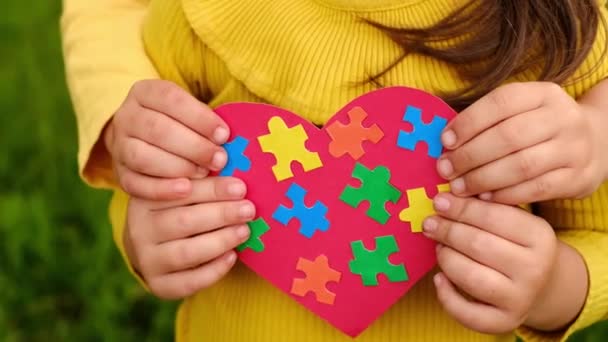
left=340, top=163, right=401, bottom=224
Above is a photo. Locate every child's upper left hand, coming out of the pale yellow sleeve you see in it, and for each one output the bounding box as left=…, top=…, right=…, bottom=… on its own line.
left=105, top=80, right=230, bottom=200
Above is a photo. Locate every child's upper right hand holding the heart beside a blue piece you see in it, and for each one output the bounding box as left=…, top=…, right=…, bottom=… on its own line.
left=437, top=82, right=608, bottom=204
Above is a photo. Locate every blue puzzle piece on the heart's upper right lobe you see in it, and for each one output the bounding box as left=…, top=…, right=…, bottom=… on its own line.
left=397, top=106, right=448, bottom=159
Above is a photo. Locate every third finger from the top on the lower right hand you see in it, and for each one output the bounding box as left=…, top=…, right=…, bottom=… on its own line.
left=437, top=245, right=513, bottom=308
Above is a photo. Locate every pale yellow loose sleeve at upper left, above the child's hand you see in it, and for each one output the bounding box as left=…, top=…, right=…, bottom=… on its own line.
left=61, top=0, right=158, bottom=187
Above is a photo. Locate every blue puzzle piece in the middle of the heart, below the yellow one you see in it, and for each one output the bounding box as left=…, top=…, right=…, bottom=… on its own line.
left=272, top=183, right=329, bottom=239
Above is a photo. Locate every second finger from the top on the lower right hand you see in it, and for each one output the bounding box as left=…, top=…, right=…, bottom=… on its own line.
left=423, top=216, right=525, bottom=278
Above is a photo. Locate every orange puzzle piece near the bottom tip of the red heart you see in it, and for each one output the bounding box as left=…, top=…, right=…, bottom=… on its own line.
left=291, top=255, right=342, bottom=305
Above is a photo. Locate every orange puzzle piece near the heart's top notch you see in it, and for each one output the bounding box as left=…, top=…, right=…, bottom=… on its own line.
left=327, top=107, right=384, bottom=160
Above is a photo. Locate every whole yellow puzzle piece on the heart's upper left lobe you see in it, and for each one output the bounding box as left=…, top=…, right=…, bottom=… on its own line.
left=258, top=116, right=323, bottom=181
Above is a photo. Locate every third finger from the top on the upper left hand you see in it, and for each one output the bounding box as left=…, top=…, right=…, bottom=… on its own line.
left=119, top=138, right=202, bottom=178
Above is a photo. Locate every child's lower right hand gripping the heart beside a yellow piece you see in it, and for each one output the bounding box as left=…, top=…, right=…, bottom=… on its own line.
left=424, top=194, right=560, bottom=334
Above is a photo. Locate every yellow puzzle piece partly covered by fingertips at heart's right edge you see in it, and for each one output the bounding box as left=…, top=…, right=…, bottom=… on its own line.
left=399, top=184, right=450, bottom=233
